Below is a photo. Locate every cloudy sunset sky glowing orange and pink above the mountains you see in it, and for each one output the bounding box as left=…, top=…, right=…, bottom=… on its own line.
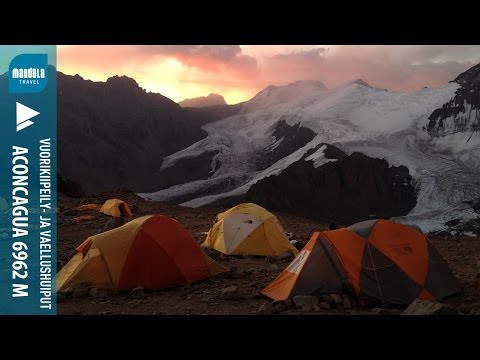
left=57, top=45, right=480, bottom=104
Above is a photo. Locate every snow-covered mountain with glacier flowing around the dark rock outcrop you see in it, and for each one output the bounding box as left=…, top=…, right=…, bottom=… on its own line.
left=141, top=69, right=480, bottom=231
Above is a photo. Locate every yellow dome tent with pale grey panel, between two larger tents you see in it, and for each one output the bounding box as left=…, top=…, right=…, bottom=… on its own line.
left=202, top=203, right=298, bottom=256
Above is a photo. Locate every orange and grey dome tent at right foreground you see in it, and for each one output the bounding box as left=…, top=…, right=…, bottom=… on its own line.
left=262, top=220, right=461, bottom=305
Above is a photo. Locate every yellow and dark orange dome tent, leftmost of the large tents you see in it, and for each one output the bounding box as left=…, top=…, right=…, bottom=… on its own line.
left=57, top=215, right=226, bottom=291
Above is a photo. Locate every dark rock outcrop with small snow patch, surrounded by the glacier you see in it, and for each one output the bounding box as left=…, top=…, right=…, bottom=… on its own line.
left=244, top=144, right=416, bottom=224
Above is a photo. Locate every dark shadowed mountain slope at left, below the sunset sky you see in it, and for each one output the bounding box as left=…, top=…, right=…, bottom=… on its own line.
left=58, top=72, right=240, bottom=192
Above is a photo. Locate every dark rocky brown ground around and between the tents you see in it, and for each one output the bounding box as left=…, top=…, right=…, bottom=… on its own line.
left=58, top=191, right=480, bottom=315
